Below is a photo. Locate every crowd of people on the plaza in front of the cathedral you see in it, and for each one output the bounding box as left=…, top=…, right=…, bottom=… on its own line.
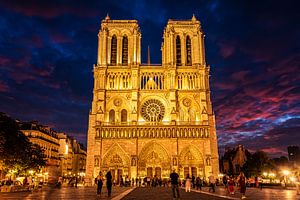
left=91, top=171, right=300, bottom=199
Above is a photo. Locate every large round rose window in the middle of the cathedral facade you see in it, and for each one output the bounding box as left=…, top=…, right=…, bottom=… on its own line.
left=141, top=99, right=165, bottom=122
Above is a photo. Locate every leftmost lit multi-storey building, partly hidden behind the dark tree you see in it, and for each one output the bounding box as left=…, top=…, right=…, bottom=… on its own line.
left=19, top=121, right=60, bottom=182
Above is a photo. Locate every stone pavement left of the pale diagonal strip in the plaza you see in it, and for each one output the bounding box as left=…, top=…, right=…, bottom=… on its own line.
left=0, top=187, right=131, bottom=200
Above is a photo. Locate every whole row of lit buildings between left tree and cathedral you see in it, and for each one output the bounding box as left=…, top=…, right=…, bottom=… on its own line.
left=19, top=121, right=86, bottom=182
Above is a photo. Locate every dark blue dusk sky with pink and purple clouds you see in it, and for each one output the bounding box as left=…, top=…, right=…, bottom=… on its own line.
left=0, top=0, right=300, bottom=156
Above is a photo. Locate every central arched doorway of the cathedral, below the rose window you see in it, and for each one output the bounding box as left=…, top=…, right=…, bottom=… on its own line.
left=138, top=142, right=171, bottom=178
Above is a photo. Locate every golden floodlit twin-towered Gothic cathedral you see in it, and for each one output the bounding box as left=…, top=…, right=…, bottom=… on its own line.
left=86, top=16, right=219, bottom=183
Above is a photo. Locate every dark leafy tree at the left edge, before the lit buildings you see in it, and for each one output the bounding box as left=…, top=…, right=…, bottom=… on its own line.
left=0, top=113, right=46, bottom=174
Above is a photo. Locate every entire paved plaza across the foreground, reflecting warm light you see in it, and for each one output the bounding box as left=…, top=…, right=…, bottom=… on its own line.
left=0, top=187, right=300, bottom=200
